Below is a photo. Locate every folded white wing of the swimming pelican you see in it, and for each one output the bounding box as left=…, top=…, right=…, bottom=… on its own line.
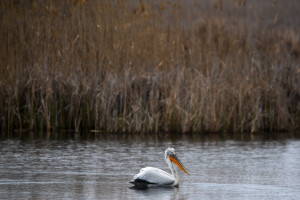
left=134, top=167, right=175, bottom=185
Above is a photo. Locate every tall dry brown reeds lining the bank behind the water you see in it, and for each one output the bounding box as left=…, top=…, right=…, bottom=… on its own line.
left=0, top=1, right=300, bottom=132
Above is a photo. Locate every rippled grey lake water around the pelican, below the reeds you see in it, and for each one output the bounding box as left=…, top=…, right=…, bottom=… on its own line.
left=0, top=133, right=300, bottom=200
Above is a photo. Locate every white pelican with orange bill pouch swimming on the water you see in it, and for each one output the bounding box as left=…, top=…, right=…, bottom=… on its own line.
left=129, top=148, right=190, bottom=188
